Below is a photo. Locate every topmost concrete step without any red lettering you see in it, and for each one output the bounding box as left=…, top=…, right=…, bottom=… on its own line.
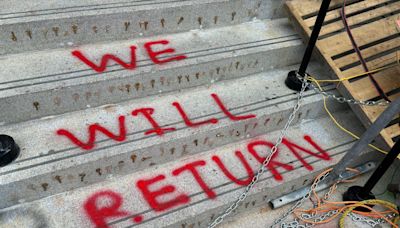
left=0, top=0, right=282, bottom=55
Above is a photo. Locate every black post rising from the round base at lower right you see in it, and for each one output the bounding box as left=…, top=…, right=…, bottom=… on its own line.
left=362, top=140, right=400, bottom=194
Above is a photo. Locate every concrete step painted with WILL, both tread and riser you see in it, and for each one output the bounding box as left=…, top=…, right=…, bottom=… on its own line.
left=0, top=65, right=345, bottom=208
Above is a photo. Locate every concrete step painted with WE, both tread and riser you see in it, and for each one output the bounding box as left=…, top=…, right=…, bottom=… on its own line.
left=0, top=19, right=303, bottom=124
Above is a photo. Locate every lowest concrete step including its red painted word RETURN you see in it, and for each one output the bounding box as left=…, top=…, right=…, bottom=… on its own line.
left=0, top=111, right=376, bottom=228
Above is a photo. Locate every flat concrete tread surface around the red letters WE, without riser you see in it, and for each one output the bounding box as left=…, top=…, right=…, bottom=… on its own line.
left=0, top=19, right=301, bottom=96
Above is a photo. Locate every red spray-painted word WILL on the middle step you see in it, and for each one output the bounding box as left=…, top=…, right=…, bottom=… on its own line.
left=56, top=94, right=256, bottom=150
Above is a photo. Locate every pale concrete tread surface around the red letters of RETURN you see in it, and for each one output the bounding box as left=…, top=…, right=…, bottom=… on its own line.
left=2, top=111, right=363, bottom=227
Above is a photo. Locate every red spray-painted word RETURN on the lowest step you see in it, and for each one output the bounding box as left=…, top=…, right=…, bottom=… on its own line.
left=83, top=135, right=331, bottom=227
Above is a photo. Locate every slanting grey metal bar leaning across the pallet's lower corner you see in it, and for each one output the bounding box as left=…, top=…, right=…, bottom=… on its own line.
left=328, top=98, right=400, bottom=181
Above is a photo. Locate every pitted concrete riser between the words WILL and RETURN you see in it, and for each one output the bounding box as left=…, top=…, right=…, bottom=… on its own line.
left=0, top=97, right=343, bottom=208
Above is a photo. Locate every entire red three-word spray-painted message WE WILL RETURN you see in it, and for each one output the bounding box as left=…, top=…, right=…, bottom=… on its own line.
left=69, top=37, right=331, bottom=228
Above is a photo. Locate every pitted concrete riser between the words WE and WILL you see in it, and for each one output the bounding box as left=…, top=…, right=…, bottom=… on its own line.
left=0, top=40, right=303, bottom=124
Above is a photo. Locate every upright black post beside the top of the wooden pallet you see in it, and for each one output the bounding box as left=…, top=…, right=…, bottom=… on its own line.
left=299, top=0, right=331, bottom=76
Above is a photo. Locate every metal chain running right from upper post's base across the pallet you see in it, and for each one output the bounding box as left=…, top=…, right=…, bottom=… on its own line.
left=297, top=74, right=390, bottom=106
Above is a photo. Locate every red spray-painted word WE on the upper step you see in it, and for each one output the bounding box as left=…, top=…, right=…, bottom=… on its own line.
left=72, top=40, right=186, bottom=73
